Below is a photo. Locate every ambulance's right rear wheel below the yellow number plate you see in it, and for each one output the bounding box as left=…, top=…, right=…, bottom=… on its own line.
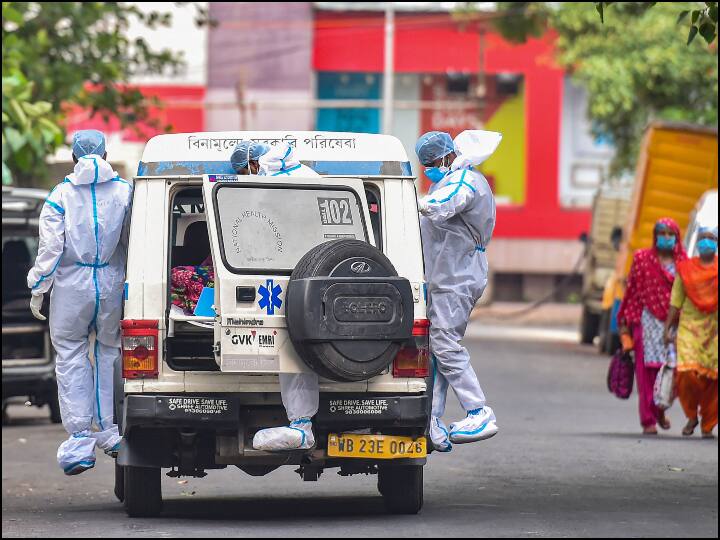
left=378, top=465, right=423, bottom=514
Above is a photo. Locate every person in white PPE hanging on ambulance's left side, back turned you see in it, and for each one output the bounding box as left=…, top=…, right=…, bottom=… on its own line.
left=27, top=130, right=132, bottom=475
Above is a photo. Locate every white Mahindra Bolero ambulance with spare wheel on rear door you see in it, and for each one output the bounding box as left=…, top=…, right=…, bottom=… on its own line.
left=115, top=132, right=432, bottom=516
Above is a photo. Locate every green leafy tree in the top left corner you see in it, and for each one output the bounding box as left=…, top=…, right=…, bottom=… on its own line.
left=2, top=2, right=207, bottom=185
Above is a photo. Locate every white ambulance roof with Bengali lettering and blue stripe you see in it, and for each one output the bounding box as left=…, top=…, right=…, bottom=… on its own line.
left=138, top=131, right=412, bottom=177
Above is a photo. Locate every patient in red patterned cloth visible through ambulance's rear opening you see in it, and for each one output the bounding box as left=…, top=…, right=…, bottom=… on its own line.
left=170, top=221, right=215, bottom=316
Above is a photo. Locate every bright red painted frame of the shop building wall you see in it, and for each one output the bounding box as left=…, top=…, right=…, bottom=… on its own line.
left=313, top=12, right=590, bottom=239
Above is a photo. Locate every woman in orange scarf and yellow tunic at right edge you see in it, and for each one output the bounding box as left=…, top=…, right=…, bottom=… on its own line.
left=665, top=227, right=718, bottom=439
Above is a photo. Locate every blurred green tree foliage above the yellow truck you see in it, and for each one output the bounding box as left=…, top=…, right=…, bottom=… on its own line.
left=486, top=2, right=718, bottom=174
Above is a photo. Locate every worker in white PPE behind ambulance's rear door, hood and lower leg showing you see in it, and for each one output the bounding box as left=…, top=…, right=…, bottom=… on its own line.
left=226, top=141, right=320, bottom=451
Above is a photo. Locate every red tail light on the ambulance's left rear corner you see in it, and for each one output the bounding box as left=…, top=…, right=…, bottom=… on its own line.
left=122, top=319, right=158, bottom=379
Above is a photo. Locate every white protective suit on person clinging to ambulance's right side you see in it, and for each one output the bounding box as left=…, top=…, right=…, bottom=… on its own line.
left=419, top=131, right=500, bottom=442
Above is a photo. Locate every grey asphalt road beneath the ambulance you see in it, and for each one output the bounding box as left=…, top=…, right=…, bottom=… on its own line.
left=2, top=323, right=718, bottom=538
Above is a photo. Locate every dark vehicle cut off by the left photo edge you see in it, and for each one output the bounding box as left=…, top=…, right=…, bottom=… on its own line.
left=2, top=186, right=61, bottom=423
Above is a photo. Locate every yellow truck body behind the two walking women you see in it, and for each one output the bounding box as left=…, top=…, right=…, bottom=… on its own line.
left=599, top=122, right=718, bottom=354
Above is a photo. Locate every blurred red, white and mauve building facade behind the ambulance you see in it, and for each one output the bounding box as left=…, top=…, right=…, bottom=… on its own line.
left=60, top=2, right=612, bottom=300
